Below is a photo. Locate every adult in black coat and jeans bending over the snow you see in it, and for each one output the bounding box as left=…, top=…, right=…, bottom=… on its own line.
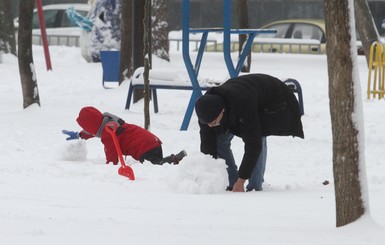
left=195, top=74, right=304, bottom=192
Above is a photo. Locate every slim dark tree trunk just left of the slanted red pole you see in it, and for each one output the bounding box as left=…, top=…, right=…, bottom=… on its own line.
left=18, top=0, right=40, bottom=108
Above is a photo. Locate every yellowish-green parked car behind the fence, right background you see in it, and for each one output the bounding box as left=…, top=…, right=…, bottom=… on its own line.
left=253, top=19, right=363, bottom=54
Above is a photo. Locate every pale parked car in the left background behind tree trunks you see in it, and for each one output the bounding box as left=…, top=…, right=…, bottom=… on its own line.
left=14, top=4, right=91, bottom=46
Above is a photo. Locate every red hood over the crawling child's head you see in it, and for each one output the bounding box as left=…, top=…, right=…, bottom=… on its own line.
left=76, top=106, right=103, bottom=135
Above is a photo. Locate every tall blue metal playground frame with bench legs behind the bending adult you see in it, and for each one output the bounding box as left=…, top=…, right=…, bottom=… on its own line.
left=126, top=0, right=276, bottom=130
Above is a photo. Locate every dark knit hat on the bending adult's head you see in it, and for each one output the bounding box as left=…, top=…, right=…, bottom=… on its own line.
left=195, top=94, right=224, bottom=124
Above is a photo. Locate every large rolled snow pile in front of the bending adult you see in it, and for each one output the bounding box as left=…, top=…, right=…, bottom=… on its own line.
left=167, top=153, right=228, bottom=194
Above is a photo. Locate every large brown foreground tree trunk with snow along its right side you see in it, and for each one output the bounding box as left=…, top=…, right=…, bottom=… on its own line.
left=325, top=0, right=365, bottom=227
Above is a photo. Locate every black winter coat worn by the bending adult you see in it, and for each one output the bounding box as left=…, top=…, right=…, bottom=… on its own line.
left=199, top=74, right=304, bottom=179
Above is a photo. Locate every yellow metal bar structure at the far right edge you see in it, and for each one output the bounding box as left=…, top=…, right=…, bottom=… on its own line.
left=368, top=42, right=385, bottom=99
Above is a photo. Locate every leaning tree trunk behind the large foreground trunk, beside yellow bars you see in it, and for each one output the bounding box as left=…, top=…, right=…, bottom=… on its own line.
left=354, top=0, right=380, bottom=65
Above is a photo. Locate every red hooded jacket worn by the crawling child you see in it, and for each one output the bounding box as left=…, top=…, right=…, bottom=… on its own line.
left=76, top=107, right=162, bottom=164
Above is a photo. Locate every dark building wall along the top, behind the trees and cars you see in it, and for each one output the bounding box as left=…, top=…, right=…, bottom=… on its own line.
left=8, top=0, right=385, bottom=34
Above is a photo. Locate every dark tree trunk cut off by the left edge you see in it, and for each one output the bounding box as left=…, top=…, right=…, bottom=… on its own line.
left=0, top=0, right=16, bottom=55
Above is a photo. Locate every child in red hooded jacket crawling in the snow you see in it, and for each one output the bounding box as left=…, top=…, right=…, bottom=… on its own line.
left=62, top=106, right=187, bottom=165
